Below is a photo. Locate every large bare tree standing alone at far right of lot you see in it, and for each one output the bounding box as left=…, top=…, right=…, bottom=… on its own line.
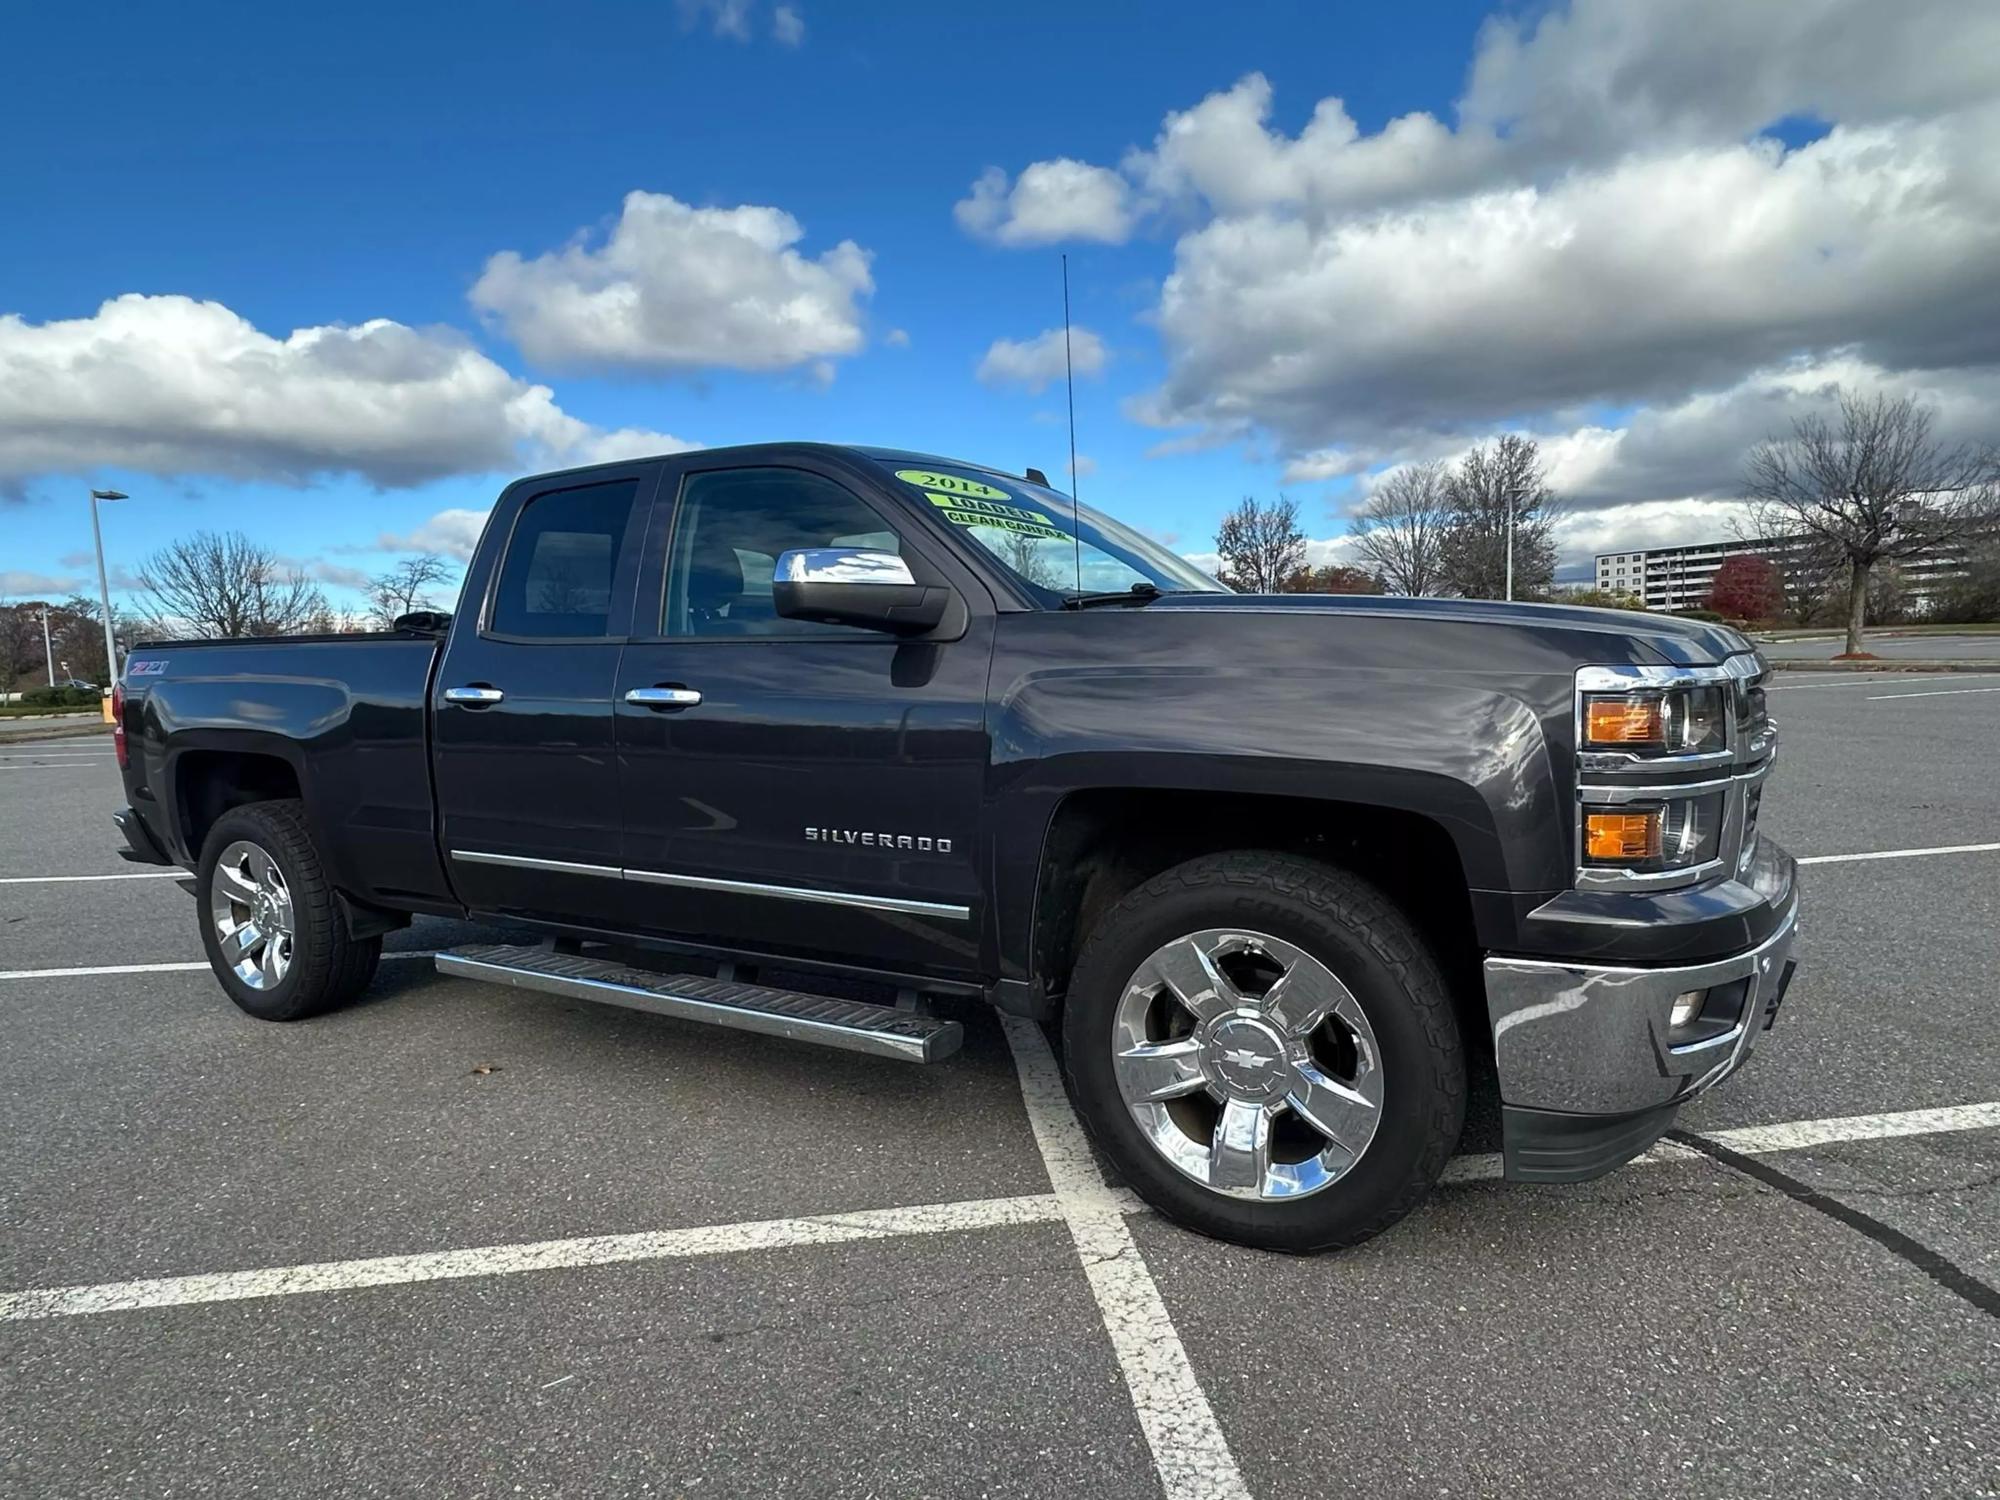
left=1744, top=390, right=2000, bottom=656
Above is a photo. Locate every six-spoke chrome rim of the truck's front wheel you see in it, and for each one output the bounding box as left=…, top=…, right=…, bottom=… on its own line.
left=1112, top=928, right=1382, bottom=1198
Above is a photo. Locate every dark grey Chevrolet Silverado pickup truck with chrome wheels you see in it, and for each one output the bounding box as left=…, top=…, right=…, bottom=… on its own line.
left=114, top=444, right=1798, bottom=1250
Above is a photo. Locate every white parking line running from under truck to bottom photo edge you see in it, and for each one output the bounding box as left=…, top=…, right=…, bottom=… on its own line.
left=1000, top=1014, right=1250, bottom=1500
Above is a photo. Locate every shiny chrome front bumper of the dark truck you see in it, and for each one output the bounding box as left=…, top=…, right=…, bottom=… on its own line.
left=1486, top=864, right=1798, bottom=1182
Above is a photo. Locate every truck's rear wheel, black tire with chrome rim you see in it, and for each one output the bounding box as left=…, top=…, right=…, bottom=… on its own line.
left=194, top=798, right=382, bottom=1020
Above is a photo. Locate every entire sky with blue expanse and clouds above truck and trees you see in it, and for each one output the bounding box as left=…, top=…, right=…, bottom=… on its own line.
left=0, top=0, right=2000, bottom=612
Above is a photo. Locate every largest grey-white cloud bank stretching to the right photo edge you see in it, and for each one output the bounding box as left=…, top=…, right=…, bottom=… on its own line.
left=1152, top=110, right=2000, bottom=446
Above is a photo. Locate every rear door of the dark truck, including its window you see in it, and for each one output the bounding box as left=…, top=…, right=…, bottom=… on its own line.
left=432, top=462, right=660, bottom=926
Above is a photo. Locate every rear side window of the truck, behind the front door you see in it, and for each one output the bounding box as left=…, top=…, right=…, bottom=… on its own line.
left=488, top=480, right=638, bottom=636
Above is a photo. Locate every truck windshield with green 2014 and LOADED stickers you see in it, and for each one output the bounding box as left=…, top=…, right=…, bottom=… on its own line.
left=890, top=460, right=1228, bottom=608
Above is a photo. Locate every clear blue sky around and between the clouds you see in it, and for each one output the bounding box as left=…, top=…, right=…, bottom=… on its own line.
left=0, top=0, right=1482, bottom=604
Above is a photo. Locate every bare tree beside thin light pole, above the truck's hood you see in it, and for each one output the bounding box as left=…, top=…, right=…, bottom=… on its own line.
left=1440, top=432, right=1556, bottom=598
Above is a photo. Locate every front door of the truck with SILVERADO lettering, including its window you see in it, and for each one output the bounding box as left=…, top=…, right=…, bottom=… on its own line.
left=616, top=458, right=992, bottom=976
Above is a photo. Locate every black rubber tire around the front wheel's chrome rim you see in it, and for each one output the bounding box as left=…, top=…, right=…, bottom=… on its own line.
left=1062, top=862, right=1464, bottom=1250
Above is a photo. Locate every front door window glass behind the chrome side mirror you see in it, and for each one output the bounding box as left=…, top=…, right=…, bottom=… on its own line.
left=662, top=468, right=902, bottom=640
